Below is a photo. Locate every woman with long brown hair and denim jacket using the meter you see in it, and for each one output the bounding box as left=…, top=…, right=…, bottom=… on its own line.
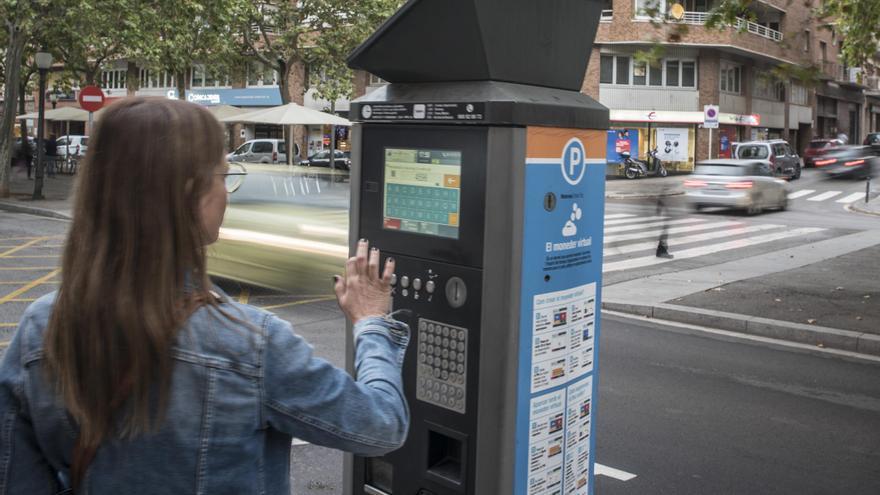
left=0, top=98, right=409, bottom=495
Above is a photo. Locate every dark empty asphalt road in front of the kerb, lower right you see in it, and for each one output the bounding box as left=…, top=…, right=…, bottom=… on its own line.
left=596, top=315, right=880, bottom=495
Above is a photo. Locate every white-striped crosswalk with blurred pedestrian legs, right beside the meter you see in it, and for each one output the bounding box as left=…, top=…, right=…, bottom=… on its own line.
left=602, top=213, right=825, bottom=273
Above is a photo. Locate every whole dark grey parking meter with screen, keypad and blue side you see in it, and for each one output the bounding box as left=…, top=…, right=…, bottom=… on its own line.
left=345, top=0, right=608, bottom=495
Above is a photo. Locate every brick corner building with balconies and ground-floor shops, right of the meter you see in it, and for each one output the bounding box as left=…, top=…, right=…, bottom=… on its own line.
left=583, top=0, right=880, bottom=172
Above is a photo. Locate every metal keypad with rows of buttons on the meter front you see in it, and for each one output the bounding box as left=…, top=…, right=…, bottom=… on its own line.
left=416, top=318, right=467, bottom=414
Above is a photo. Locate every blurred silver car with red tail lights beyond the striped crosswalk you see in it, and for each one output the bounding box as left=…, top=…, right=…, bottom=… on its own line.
left=684, top=159, right=788, bottom=214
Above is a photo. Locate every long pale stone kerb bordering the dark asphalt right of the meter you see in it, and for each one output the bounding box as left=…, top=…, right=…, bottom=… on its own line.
left=602, top=301, right=880, bottom=356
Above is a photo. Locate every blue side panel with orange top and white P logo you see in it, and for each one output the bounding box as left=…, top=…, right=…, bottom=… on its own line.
left=515, top=128, right=606, bottom=495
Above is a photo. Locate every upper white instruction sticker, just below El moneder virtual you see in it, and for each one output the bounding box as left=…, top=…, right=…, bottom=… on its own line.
left=531, top=282, right=596, bottom=393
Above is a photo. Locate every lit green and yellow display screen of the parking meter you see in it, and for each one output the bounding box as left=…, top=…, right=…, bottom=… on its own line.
left=382, top=148, right=461, bottom=239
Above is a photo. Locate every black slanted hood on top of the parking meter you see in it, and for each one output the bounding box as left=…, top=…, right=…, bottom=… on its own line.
left=348, top=0, right=602, bottom=91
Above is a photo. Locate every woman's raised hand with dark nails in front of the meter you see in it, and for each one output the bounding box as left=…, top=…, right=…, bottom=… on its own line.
left=333, top=239, right=394, bottom=323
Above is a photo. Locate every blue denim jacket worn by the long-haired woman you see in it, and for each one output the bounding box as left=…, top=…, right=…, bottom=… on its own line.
left=0, top=294, right=409, bottom=495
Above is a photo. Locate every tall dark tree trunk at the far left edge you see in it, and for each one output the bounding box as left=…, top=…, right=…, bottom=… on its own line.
left=0, top=26, right=25, bottom=198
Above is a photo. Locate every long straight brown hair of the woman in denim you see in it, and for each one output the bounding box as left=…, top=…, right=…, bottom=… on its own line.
left=44, top=98, right=223, bottom=484
